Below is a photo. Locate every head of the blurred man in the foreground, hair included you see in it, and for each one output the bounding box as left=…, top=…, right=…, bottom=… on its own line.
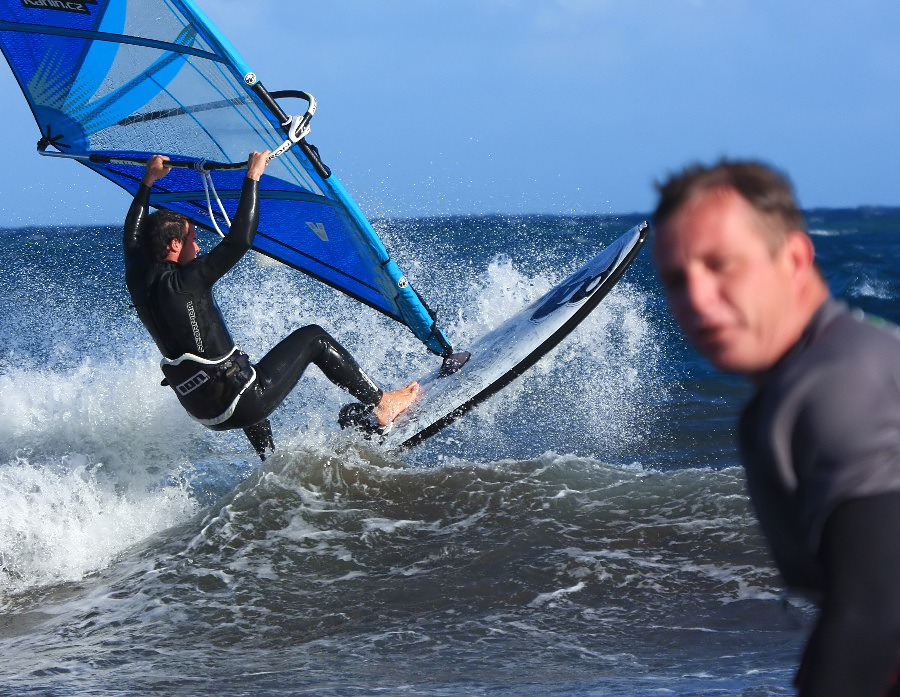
left=654, top=161, right=828, bottom=378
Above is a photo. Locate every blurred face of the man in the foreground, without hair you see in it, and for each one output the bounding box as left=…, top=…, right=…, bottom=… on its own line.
left=654, top=189, right=797, bottom=376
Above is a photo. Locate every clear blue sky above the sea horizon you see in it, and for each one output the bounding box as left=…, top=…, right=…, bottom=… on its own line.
left=0, top=0, right=900, bottom=226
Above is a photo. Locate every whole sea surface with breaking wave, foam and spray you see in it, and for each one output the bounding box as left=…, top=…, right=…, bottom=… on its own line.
left=0, top=208, right=900, bottom=697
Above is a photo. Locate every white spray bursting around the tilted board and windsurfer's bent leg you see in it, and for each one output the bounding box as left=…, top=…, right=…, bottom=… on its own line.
left=218, top=237, right=665, bottom=464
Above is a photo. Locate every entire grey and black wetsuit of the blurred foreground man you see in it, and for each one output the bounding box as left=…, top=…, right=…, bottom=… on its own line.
left=740, top=299, right=900, bottom=697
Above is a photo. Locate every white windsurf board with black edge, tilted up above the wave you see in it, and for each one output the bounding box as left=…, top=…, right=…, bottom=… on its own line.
left=380, top=222, right=649, bottom=450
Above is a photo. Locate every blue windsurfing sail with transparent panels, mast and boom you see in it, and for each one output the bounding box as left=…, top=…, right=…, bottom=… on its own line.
left=0, top=0, right=452, bottom=357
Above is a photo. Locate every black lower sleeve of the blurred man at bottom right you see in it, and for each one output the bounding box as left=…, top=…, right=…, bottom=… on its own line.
left=797, top=492, right=900, bottom=697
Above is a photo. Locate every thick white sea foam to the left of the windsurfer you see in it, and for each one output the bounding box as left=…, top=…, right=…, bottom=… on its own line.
left=0, top=357, right=210, bottom=593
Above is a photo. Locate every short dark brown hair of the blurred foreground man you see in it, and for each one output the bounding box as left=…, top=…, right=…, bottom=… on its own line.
left=653, top=159, right=806, bottom=248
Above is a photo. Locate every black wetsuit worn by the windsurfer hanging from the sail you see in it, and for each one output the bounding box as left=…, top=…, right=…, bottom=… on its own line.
left=123, top=178, right=382, bottom=458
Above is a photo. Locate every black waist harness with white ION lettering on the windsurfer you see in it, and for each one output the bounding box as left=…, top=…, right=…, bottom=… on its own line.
left=160, top=347, right=256, bottom=426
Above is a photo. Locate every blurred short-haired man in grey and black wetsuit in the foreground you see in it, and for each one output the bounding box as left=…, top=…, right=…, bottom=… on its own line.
left=654, top=161, right=900, bottom=697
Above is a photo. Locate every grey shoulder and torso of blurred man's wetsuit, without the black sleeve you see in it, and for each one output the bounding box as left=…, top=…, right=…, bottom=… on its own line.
left=740, top=299, right=900, bottom=588
